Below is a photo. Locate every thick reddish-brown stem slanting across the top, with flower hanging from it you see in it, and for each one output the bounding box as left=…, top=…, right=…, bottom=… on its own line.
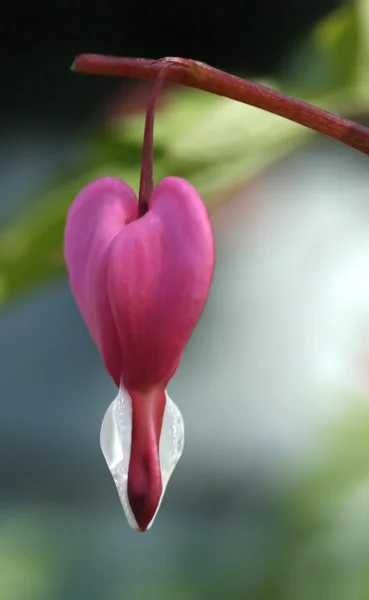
left=72, top=54, right=369, bottom=154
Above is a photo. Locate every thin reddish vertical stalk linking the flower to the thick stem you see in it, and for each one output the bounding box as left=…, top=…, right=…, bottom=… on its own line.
left=138, top=63, right=172, bottom=218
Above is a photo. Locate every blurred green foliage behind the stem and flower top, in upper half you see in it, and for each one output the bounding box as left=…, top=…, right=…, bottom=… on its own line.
left=0, top=0, right=369, bottom=303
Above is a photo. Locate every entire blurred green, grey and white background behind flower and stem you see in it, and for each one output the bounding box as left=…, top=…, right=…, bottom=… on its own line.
left=0, top=0, right=369, bottom=600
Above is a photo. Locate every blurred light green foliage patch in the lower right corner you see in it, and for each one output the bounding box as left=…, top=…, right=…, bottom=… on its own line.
left=274, top=402, right=369, bottom=600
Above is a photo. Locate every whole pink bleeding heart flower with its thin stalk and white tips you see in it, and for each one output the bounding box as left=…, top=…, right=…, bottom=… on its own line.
left=65, top=65, right=214, bottom=531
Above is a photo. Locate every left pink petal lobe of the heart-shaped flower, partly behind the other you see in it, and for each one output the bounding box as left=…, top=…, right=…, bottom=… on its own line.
left=64, top=177, right=137, bottom=385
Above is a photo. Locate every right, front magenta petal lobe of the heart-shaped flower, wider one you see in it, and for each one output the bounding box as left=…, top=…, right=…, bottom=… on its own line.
left=108, top=177, right=214, bottom=389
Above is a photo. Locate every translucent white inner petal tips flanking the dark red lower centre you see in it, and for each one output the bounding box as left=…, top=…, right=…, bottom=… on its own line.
left=100, top=385, right=184, bottom=529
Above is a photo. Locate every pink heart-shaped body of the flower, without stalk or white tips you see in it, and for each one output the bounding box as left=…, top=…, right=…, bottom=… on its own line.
left=65, top=177, right=214, bottom=390
